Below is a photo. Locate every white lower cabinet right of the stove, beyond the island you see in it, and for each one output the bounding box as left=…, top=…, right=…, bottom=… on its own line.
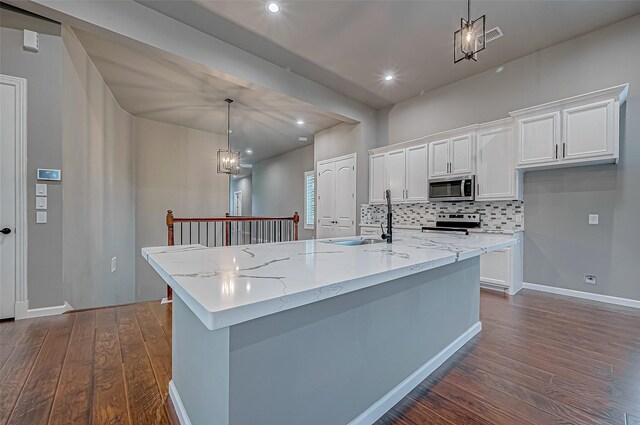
left=480, top=232, right=523, bottom=295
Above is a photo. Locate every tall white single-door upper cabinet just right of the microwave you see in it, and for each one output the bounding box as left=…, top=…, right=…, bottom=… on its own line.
left=476, top=127, right=516, bottom=200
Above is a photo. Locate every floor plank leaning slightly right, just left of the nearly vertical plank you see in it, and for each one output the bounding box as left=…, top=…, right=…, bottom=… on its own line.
left=49, top=310, right=96, bottom=425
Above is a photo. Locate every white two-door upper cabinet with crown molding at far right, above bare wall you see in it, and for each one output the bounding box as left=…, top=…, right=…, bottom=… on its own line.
left=511, top=84, right=628, bottom=169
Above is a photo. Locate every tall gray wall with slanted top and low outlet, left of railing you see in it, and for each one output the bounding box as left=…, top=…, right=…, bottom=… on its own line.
left=60, top=27, right=135, bottom=308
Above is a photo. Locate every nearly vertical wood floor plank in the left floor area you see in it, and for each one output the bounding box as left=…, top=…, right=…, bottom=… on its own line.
left=91, top=308, right=131, bottom=425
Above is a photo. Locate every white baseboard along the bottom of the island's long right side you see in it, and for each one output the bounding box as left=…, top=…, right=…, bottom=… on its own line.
left=349, top=322, right=482, bottom=425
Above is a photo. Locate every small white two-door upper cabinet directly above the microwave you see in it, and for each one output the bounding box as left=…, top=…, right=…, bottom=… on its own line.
left=429, top=134, right=474, bottom=179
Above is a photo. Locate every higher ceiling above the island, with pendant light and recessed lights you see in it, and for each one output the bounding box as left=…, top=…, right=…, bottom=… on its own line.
left=139, top=0, right=640, bottom=108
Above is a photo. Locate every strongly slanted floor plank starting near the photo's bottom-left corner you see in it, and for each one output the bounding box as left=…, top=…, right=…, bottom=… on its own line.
left=7, top=315, right=75, bottom=425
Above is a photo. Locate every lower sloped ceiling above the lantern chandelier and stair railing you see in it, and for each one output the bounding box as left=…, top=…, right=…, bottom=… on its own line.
left=74, top=29, right=348, bottom=164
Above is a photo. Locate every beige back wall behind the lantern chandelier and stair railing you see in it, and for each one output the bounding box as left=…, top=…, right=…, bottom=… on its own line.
left=134, top=117, right=229, bottom=301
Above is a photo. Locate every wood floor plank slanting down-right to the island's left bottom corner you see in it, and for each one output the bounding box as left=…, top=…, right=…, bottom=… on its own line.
left=116, top=306, right=168, bottom=425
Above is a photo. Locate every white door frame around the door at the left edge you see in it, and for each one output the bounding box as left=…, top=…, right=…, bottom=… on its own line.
left=0, top=74, right=29, bottom=319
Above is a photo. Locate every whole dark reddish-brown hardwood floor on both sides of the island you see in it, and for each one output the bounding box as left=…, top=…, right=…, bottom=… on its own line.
left=0, top=290, right=640, bottom=425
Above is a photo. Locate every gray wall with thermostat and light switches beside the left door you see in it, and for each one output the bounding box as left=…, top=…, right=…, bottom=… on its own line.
left=0, top=9, right=68, bottom=308
